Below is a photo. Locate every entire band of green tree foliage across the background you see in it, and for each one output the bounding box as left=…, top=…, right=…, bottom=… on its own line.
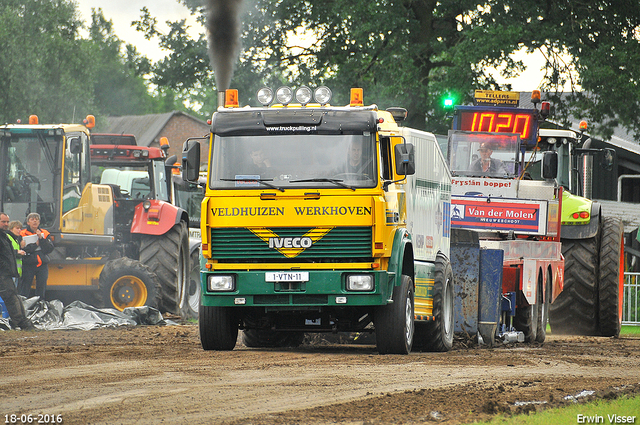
left=0, top=0, right=640, bottom=138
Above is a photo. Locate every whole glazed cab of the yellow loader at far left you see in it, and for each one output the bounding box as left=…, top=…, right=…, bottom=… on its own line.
left=0, top=120, right=90, bottom=233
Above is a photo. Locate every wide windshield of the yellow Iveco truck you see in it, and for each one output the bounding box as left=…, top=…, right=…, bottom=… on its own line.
left=209, top=134, right=378, bottom=189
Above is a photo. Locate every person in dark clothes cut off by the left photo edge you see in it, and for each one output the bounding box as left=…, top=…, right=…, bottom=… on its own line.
left=0, top=212, right=35, bottom=330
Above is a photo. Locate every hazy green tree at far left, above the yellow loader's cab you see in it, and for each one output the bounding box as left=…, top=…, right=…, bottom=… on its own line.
left=0, top=0, right=92, bottom=122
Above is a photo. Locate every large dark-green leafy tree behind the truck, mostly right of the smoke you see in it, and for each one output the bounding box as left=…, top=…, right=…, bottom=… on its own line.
left=141, top=0, right=640, bottom=136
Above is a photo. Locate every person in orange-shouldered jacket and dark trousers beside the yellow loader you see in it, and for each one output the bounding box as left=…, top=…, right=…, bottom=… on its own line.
left=18, top=213, right=54, bottom=301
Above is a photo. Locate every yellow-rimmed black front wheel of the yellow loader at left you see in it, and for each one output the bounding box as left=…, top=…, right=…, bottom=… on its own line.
left=98, top=257, right=159, bottom=311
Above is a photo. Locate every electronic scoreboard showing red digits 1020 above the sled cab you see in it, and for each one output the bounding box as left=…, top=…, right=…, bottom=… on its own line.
left=453, top=106, right=538, bottom=146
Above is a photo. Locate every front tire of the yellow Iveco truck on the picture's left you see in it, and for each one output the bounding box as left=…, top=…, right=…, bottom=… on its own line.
left=198, top=305, right=238, bottom=351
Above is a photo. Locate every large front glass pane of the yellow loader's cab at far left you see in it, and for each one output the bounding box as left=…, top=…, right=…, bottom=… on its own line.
left=0, top=133, right=62, bottom=227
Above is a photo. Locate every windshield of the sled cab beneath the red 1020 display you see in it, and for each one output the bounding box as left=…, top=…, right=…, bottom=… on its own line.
left=447, top=130, right=520, bottom=178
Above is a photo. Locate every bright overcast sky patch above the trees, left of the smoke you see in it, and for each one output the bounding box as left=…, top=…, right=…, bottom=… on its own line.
left=75, top=0, right=200, bottom=61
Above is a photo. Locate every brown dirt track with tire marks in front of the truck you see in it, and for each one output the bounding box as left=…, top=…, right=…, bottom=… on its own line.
left=0, top=325, right=640, bottom=424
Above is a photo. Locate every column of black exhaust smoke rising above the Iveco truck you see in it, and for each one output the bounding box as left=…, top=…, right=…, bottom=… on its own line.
left=207, top=0, right=242, bottom=106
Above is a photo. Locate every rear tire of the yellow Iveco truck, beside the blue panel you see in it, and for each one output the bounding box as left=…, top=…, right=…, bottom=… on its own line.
left=413, top=254, right=454, bottom=352
